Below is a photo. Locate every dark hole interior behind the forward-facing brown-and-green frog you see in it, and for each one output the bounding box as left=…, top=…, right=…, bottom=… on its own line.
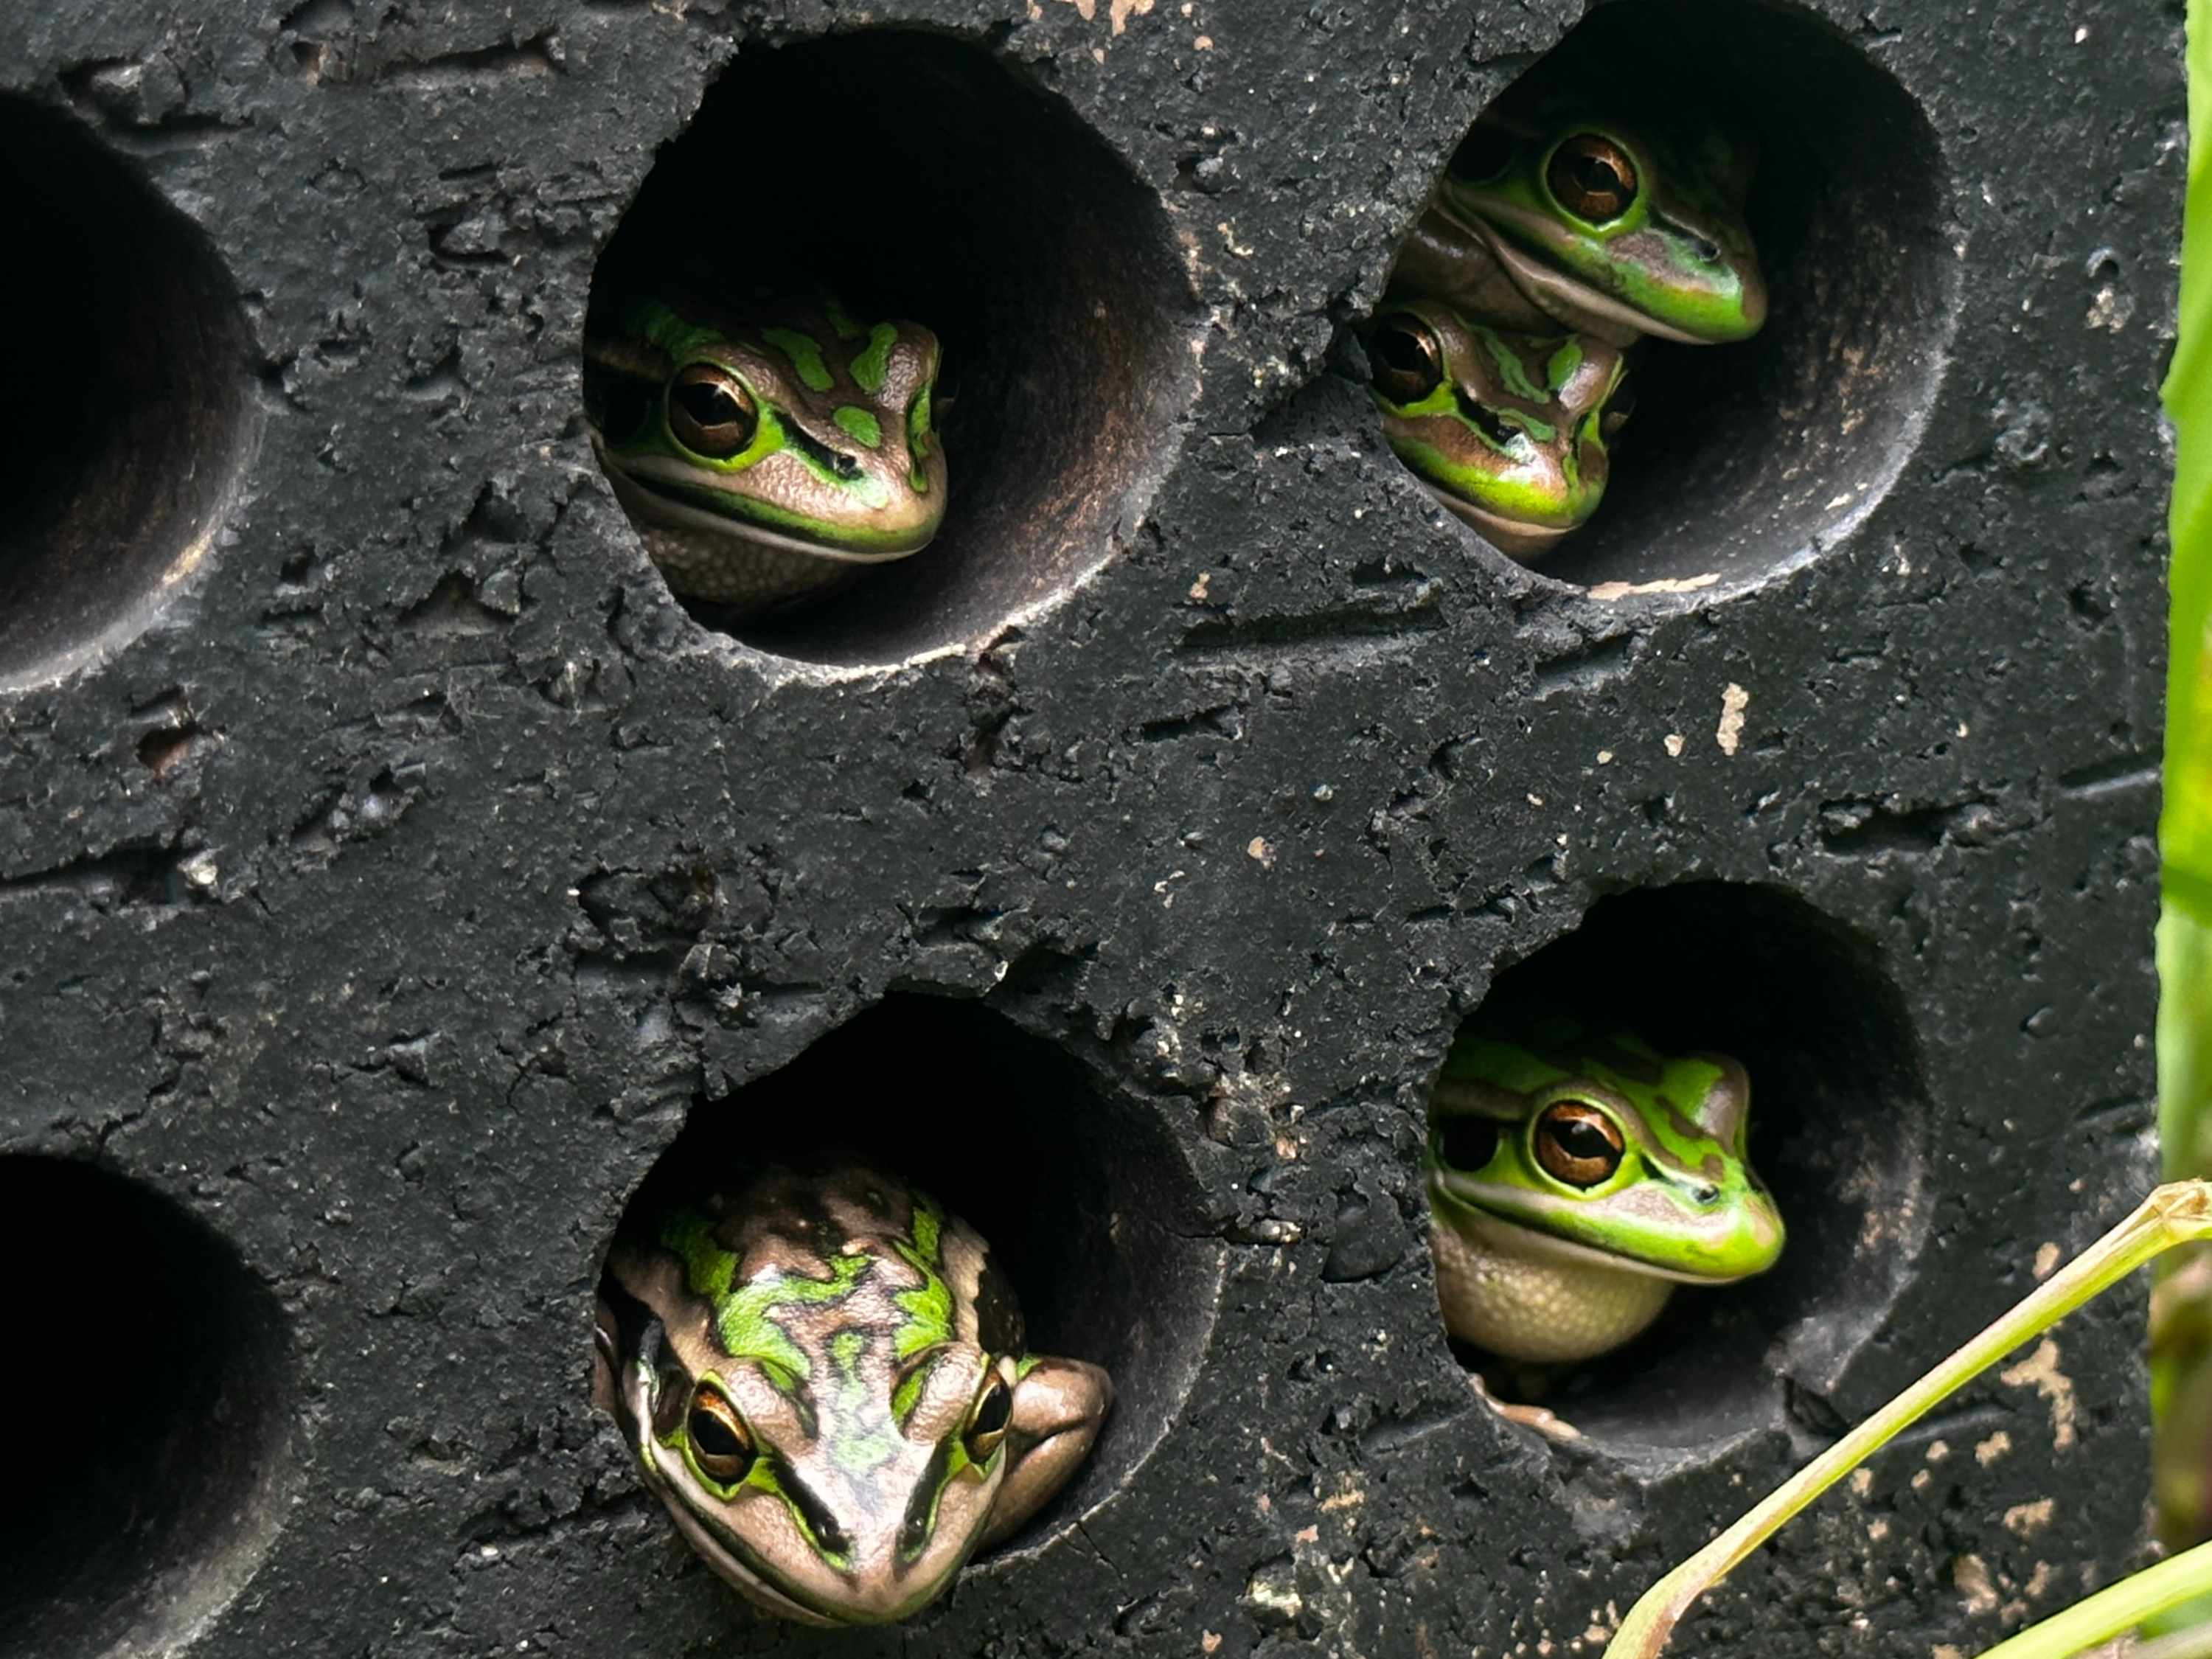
left=622, top=995, right=1223, bottom=1548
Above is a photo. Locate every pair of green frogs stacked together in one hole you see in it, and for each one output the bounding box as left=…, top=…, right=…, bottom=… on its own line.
left=1365, top=82, right=1767, bottom=562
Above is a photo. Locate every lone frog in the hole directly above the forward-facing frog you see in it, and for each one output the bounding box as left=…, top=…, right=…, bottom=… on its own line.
left=584, top=296, right=945, bottom=611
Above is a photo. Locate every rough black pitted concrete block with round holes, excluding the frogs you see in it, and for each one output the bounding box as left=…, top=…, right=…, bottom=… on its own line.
left=0, top=0, right=2185, bottom=1659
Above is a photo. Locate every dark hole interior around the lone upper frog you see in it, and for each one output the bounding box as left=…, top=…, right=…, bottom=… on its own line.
left=591, top=31, right=1192, bottom=666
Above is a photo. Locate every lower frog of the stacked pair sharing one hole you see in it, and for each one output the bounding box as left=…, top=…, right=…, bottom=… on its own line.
left=1367, top=299, right=1630, bottom=560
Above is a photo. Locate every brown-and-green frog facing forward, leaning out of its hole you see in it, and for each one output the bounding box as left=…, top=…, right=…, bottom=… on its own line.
left=597, top=1164, right=1113, bottom=1624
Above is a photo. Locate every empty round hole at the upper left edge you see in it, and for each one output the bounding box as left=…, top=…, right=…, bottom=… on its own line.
left=0, top=97, right=254, bottom=690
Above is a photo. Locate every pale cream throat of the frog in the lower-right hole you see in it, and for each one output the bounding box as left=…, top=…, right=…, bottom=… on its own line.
left=1429, top=1212, right=1674, bottom=1363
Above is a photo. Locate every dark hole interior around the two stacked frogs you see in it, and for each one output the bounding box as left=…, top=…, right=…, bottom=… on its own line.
left=1398, top=0, right=1958, bottom=595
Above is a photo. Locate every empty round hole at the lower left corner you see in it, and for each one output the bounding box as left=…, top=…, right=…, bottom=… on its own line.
left=0, top=1157, right=294, bottom=1659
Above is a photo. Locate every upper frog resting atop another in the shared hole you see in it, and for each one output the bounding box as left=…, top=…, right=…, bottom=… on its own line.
left=1389, top=100, right=1767, bottom=347
